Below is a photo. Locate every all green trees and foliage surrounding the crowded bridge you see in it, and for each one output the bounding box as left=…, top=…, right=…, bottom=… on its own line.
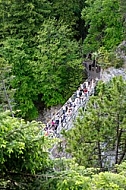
left=0, top=0, right=126, bottom=190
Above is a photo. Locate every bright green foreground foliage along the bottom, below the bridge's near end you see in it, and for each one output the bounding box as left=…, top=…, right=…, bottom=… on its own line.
left=0, top=112, right=126, bottom=190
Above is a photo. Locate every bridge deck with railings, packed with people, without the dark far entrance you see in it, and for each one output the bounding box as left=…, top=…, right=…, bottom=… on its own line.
left=41, top=79, right=97, bottom=138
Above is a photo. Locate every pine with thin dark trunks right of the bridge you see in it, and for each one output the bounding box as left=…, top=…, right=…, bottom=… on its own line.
left=65, top=77, right=126, bottom=170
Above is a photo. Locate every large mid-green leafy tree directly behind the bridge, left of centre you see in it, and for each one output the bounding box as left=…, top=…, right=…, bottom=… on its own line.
left=3, top=20, right=83, bottom=119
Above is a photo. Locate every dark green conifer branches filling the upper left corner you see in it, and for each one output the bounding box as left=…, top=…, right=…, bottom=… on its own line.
left=0, top=0, right=51, bottom=42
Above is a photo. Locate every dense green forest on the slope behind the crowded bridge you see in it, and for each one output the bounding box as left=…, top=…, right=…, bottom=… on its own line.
left=0, top=0, right=125, bottom=119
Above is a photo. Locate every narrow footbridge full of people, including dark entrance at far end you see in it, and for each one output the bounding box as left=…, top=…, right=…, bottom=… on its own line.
left=42, top=62, right=101, bottom=138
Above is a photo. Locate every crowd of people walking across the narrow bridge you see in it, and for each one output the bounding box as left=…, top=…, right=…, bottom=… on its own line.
left=41, top=80, right=95, bottom=137
